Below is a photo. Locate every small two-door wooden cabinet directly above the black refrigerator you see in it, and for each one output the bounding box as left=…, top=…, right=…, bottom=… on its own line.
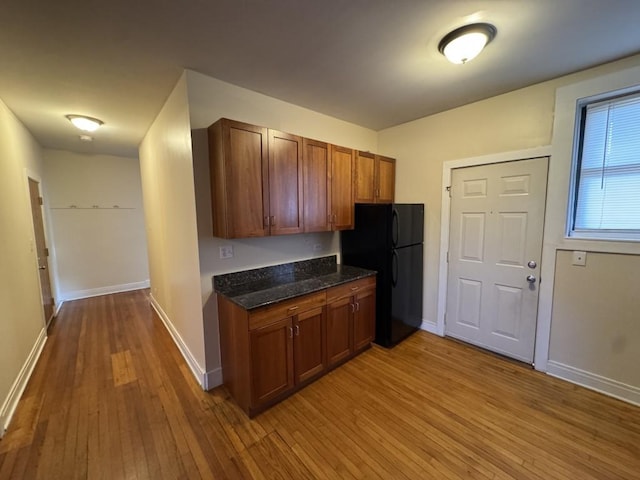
left=354, top=152, right=396, bottom=203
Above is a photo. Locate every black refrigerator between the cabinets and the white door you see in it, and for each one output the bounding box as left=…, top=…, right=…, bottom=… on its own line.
left=340, top=203, right=424, bottom=347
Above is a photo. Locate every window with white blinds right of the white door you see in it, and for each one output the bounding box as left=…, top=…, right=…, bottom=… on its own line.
left=569, top=92, right=640, bottom=240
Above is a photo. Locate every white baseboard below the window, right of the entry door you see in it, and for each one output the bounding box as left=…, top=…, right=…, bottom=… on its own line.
left=547, top=360, right=640, bottom=405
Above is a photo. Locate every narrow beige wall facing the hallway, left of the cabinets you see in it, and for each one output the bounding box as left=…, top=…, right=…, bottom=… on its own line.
left=140, top=75, right=205, bottom=383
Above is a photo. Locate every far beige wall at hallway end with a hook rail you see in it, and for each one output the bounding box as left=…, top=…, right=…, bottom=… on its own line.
left=44, top=150, right=149, bottom=300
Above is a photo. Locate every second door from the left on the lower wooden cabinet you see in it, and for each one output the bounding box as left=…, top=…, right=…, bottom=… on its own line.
left=293, top=307, right=326, bottom=383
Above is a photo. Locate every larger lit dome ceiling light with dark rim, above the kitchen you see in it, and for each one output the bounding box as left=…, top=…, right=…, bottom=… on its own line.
left=438, top=23, right=498, bottom=64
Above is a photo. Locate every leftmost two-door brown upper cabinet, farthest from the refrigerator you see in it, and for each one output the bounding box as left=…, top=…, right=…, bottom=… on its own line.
left=209, top=118, right=304, bottom=238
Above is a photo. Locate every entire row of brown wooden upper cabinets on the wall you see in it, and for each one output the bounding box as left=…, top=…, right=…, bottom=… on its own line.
left=209, top=118, right=395, bottom=238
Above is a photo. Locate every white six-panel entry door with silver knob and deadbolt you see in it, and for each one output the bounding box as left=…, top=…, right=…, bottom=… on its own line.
left=445, top=157, right=548, bottom=363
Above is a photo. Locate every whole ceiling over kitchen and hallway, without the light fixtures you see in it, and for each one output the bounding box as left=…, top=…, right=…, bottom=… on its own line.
left=0, top=0, right=640, bottom=156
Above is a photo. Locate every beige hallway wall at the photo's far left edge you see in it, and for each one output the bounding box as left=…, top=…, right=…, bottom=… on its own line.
left=0, top=96, right=46, bottom=435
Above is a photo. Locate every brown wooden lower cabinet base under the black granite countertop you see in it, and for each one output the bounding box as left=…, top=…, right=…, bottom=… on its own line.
left=218, top=277, right=375, bottom=416
